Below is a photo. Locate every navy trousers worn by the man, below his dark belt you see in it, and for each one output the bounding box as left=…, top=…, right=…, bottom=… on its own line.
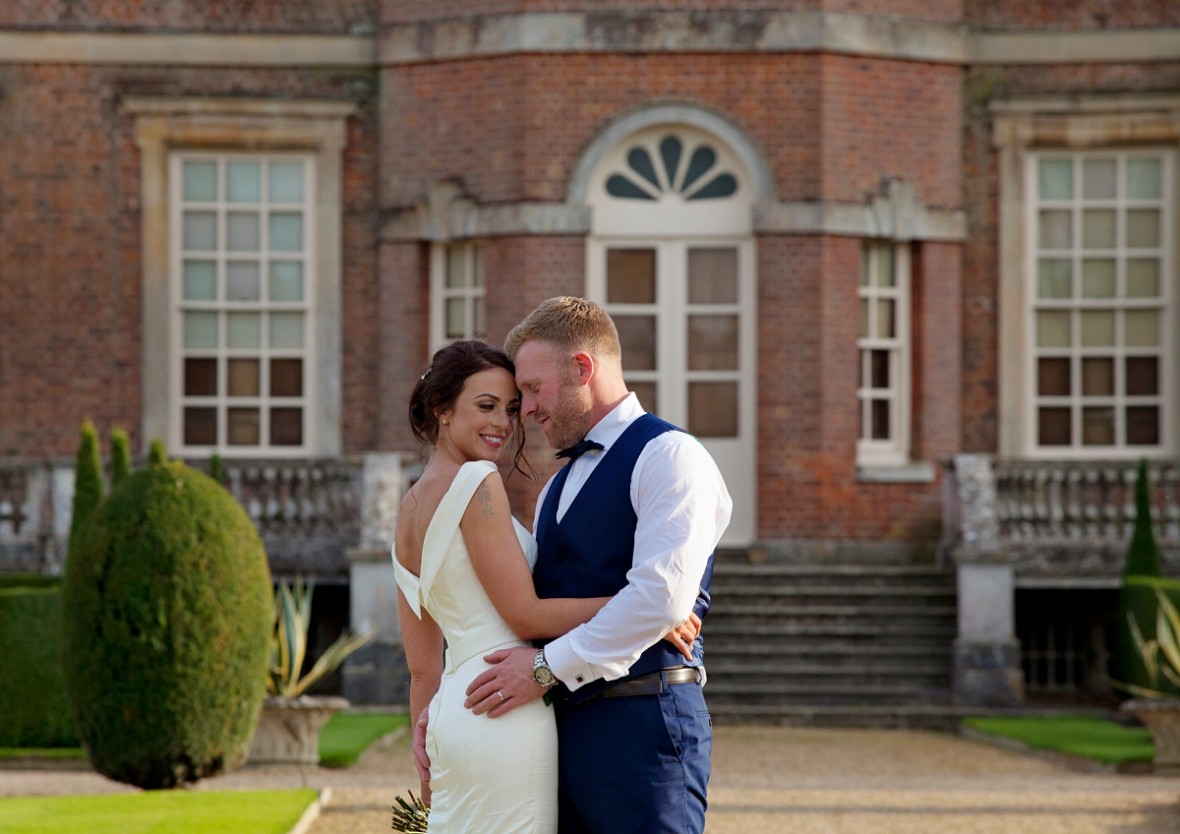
left=555, top=683, right=713, bottom=834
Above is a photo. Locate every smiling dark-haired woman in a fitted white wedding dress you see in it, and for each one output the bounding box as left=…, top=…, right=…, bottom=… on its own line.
left=393, top=341, right=691, bottom=834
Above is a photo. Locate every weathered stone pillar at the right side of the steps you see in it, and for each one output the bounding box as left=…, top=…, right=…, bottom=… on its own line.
left=951, top=454, right=1024, bottom=707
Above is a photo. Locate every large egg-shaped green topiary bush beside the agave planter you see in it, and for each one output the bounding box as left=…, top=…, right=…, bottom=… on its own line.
left=63, top=462, right=273, bottom=788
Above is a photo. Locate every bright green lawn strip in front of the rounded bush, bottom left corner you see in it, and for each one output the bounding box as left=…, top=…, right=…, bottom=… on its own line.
left=0, top=788, right=316, bottom=834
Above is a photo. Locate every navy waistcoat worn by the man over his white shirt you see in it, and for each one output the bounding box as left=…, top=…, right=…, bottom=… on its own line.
left=532, top=414, right=714, bottom=703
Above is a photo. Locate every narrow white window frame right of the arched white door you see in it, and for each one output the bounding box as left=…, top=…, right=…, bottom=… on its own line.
left=857, top=241, right=912, bottom=468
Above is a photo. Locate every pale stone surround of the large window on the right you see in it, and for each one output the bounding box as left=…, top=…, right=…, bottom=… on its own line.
left=990, top=93, right=1180, bottom=460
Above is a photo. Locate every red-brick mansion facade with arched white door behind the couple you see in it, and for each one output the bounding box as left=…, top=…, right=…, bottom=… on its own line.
left=0, top=0, right=1180, bottom=717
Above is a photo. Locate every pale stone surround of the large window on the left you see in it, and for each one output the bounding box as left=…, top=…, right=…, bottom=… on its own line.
left=122, top=97, right=356, bottom=458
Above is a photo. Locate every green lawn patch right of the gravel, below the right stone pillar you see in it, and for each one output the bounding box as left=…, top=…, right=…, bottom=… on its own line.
left=963, top=715, right=1155, bottom=764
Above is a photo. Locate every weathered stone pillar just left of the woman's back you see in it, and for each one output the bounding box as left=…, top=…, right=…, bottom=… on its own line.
left=340, top=454, right=409, bottom=704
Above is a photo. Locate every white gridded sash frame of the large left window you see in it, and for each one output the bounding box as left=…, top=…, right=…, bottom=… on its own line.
left=169, top=150, right=316, bottom=457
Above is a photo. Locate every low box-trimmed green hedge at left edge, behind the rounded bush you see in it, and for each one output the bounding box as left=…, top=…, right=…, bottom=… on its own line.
left=0, top=585, right=78, bottom=747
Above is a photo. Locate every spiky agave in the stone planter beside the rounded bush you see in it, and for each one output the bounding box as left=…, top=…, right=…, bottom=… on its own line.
left=267, top=580, right=372, bottom=698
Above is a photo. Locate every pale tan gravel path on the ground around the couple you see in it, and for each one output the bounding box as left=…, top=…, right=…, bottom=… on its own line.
left=0, top=727, right=1180, bottom=834
